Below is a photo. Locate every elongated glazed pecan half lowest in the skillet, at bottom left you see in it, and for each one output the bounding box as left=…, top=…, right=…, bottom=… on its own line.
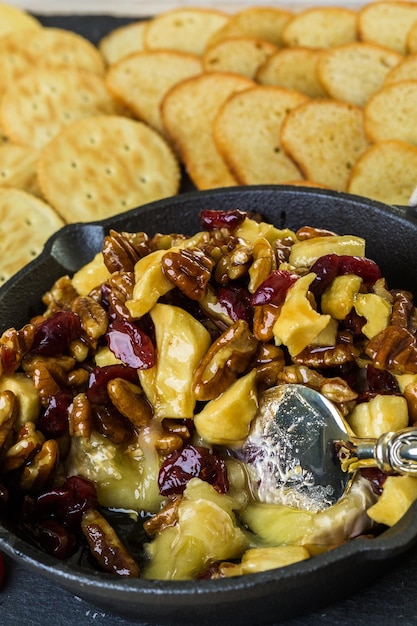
left=81, top=509, right=140, bottom=577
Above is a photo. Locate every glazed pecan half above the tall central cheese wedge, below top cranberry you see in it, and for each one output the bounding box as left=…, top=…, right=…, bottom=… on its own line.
left=161, top=248, right=214, bottom=300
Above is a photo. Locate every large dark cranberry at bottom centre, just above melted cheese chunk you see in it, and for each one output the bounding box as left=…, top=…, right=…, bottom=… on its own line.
left=158, top=445, right=229, bottom=496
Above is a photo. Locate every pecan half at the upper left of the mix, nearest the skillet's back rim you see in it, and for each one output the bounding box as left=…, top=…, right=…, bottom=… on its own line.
left=103, top=230, right=151, bottom=274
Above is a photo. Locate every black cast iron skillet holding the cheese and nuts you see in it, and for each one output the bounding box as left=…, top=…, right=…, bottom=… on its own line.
left=0, top=186, right=417, bottom=626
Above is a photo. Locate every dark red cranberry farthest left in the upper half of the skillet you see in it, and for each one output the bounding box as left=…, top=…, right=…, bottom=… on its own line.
left=31, top=311, right=81, bottom=356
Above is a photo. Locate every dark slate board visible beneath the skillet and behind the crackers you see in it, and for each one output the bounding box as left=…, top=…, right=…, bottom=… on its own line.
left=0, top=15, right=417, bottom=626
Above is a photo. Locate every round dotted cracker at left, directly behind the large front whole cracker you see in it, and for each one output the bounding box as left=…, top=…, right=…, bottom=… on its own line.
left=0, top=68, right=126, bottom=149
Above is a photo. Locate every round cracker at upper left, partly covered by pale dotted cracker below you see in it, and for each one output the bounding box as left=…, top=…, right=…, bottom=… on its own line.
left=0, top=27, right=105, bottom=94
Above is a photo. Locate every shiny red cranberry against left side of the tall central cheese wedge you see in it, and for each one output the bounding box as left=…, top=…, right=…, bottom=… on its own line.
left=106, top=319, right=155, bottom=369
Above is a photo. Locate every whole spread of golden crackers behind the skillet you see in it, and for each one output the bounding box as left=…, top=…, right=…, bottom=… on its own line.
left=0, top=0, right=417, bottom=283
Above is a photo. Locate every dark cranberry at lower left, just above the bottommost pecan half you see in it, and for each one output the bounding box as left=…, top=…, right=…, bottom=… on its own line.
left=28, top=476, right=98, bottom=529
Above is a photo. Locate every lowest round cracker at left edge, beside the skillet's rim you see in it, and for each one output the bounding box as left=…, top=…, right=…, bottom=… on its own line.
left=0, top=189, right=64, bottom=284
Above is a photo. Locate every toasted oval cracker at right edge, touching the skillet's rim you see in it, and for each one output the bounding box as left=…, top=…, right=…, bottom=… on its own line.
left=348, top=140, right=417, bottom=205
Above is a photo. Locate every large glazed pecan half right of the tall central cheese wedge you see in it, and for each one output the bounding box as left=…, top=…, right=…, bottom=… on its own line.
left=193, top=320, right=258, bottom=400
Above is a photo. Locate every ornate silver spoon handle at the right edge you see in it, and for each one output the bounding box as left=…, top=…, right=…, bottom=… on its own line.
left=344, top=428, right=417, bottom=476
